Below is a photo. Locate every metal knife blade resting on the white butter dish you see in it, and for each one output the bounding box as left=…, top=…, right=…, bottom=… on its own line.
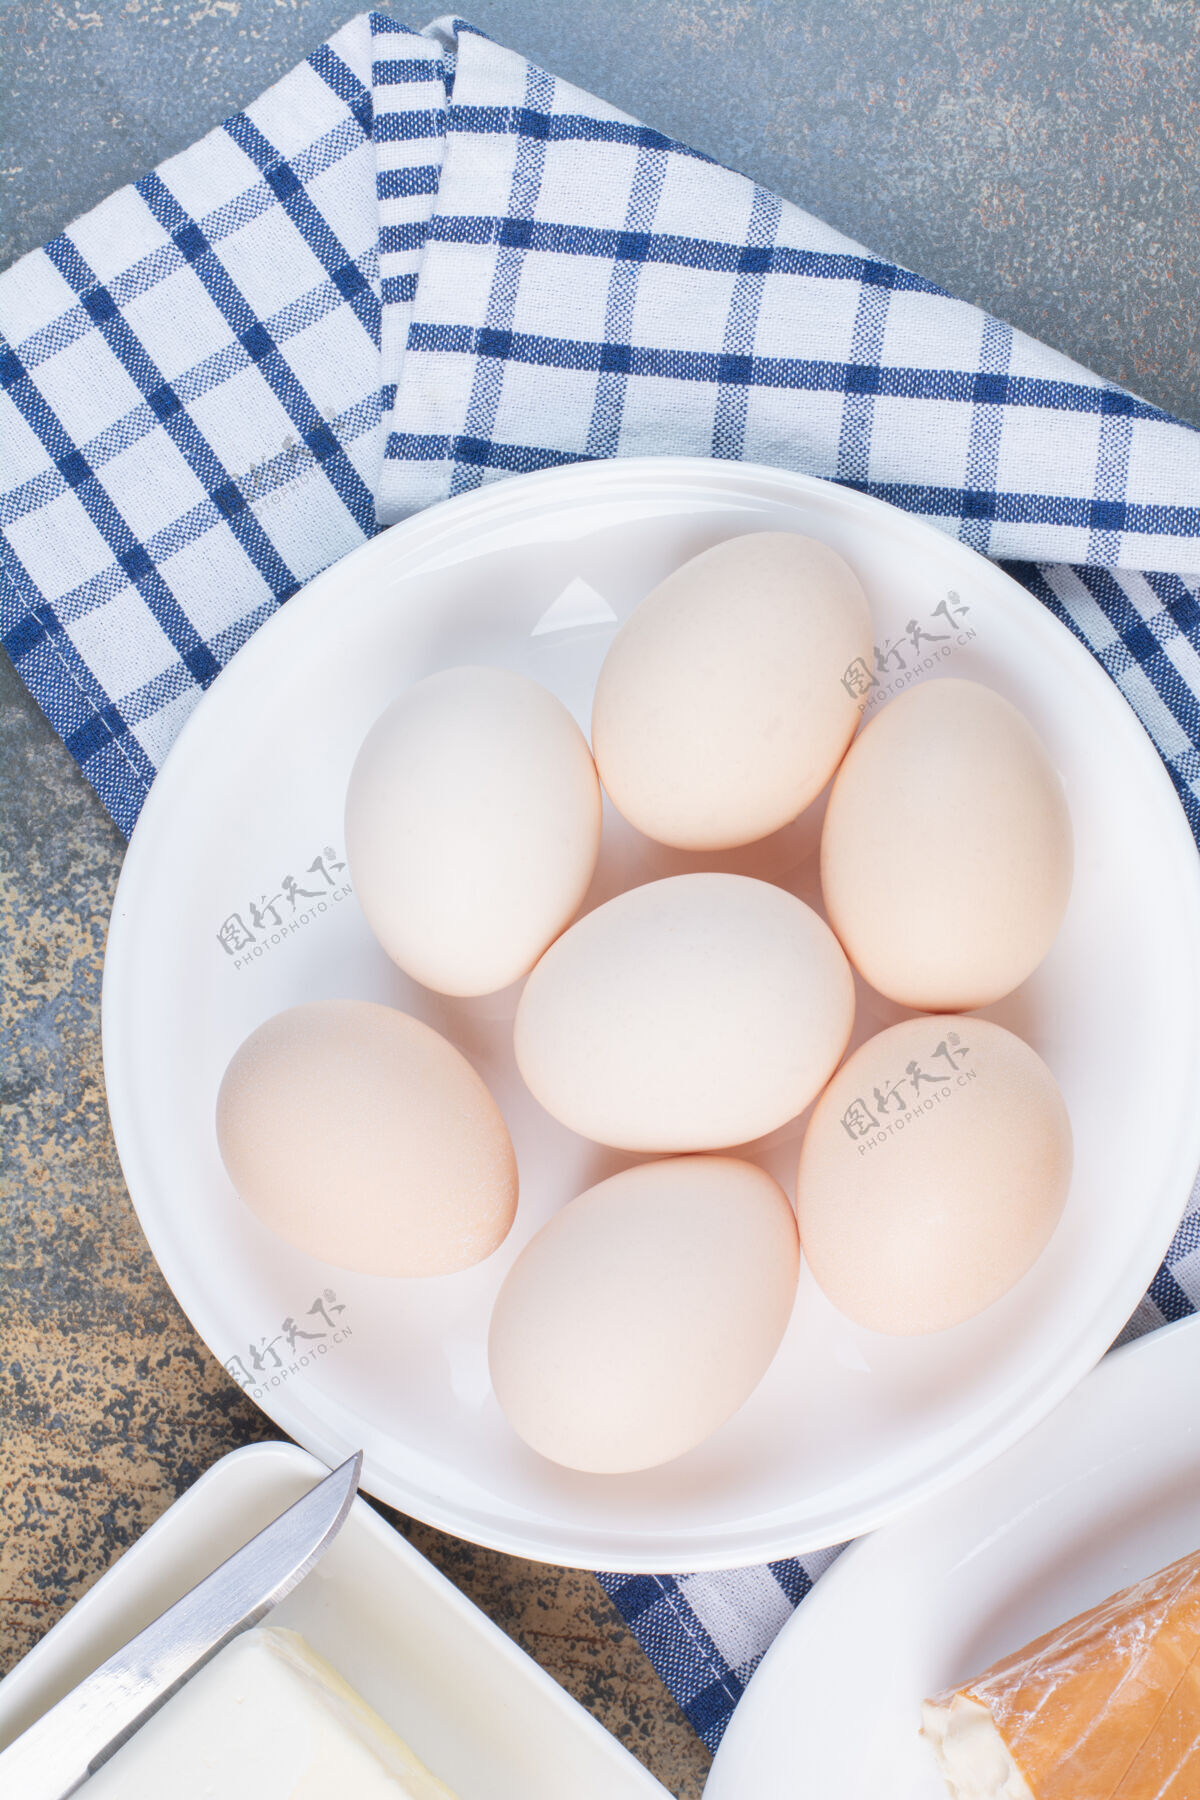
left=0, top=1451, right=362, bottom=1800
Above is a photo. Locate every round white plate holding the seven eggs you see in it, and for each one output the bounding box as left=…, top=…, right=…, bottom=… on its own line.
left=104, top=461, right=1200, bottom=1570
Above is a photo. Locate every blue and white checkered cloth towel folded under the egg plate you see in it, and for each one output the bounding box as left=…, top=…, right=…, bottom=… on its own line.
left=0, top=14, right=1200, bottom=1744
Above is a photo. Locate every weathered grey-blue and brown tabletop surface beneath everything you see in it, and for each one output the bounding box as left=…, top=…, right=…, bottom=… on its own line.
left=0, top=0, right=1200, bottom=1800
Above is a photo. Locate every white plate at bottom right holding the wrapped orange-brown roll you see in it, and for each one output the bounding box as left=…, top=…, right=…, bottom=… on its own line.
left=703, top=1318, right=1200, bottom=1800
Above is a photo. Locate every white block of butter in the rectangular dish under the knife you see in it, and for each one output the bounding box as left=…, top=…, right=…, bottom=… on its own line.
left=83, top=1625, right=453, bottom=1800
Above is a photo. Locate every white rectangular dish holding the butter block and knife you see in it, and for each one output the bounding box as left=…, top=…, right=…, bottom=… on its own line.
left=0, top=1444, right=667, bottom=1800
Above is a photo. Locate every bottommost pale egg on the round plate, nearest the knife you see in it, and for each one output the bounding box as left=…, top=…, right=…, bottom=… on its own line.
left=488, top=1156, right=799, bottom=1474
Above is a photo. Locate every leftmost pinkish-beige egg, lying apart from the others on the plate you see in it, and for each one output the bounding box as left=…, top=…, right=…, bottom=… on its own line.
left=216, top=1001, right=516, bottom=1274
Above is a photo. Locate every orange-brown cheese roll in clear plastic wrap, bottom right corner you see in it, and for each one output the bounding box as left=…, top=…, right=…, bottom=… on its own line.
left=923, top=1552, right=1200, bottom=1800
